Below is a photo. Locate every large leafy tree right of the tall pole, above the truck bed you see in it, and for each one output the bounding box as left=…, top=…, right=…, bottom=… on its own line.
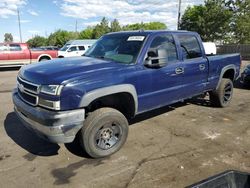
left=180, top=0, right=232, bottom=42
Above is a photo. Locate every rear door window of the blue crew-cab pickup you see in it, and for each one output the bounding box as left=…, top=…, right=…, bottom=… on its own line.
left=178, top=35, right=202, bottom=59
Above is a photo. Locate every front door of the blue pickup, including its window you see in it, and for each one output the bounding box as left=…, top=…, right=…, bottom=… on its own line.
left=138, top=33, right=183, bottom=112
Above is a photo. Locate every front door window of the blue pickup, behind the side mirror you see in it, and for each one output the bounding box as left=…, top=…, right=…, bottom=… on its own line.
left=147, top=34, right=177, bottom=63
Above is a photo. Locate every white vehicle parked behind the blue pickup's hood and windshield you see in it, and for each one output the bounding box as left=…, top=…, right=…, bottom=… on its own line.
left=58, top=40, right=96, bottom=58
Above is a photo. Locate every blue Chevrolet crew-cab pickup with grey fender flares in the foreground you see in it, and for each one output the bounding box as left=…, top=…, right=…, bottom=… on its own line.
left=13, top=31, right=241, bottom=158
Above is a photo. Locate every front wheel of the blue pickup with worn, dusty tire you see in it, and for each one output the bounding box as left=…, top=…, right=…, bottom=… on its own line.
left=80, top=108, right=129, bottom=158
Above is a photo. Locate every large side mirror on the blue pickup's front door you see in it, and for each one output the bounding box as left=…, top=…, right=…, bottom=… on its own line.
left=144, top=48, right=168, bottom=68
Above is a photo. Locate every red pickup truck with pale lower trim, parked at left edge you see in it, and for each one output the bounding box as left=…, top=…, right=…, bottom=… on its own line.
left=0, top=43, right=57, bottom=67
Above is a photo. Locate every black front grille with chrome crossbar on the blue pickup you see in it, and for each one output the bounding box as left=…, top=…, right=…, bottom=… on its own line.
left=17, top=77, right=39, bottom=106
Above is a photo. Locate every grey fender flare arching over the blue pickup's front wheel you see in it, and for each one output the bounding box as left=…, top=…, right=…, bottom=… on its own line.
left=80, top=84, right=138, bottom=114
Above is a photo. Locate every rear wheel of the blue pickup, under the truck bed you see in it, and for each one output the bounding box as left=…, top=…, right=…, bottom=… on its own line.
left=209, top=78, right=233, bottom=107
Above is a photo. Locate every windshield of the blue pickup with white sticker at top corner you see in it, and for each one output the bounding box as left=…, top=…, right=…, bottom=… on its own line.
left=85, top=33, right=146, bottom=64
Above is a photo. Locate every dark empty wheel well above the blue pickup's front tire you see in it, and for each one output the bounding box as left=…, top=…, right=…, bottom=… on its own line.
left=86, top=92, right=135, bottom=118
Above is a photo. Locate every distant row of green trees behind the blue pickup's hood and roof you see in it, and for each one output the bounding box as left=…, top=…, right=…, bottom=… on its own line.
left=25, top=17, right=167, bottom=47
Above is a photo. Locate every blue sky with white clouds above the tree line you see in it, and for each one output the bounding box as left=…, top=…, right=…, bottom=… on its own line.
left=0, top=0, right=204, bottom=42
